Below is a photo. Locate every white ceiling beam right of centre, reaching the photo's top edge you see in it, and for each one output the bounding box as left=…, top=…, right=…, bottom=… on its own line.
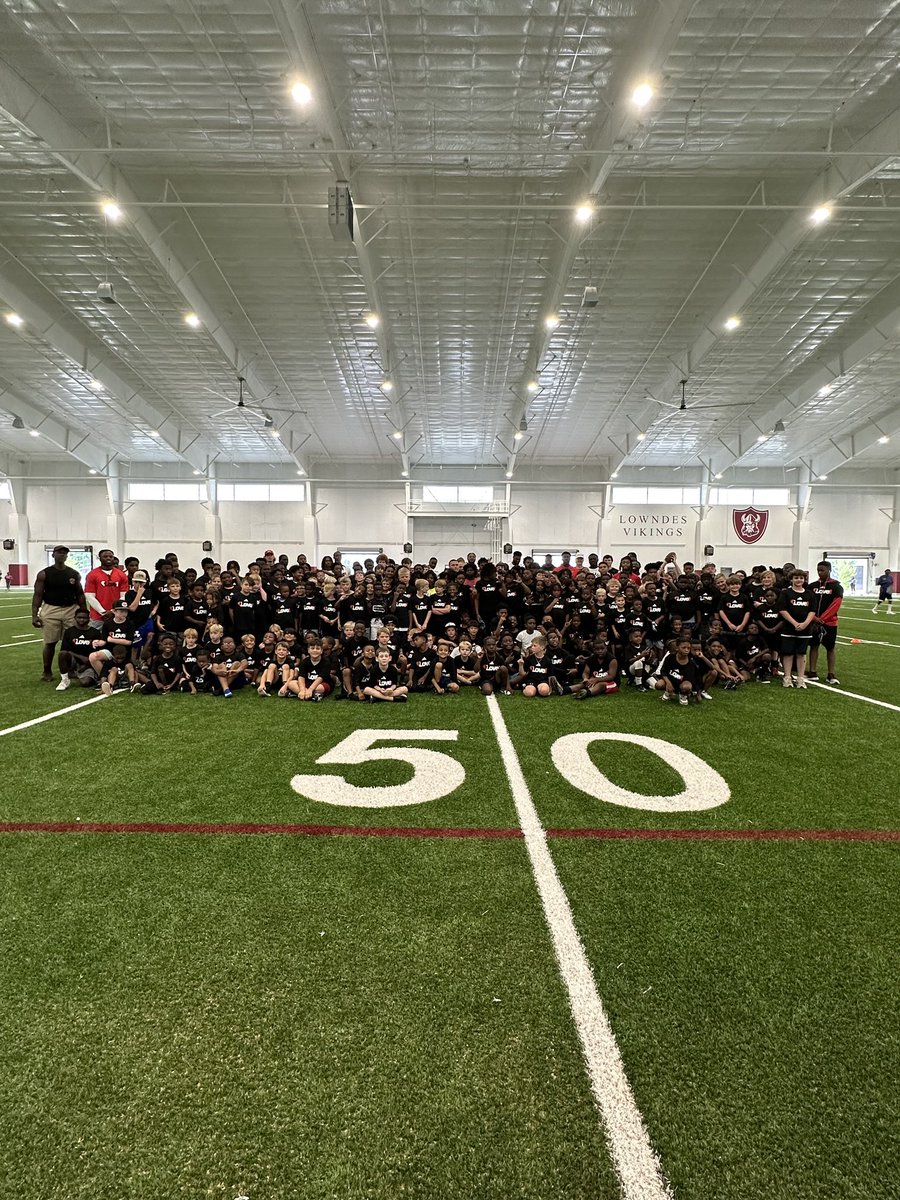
left=506, top=0, right=697, bottom=473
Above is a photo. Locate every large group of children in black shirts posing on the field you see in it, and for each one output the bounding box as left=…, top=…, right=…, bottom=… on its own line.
left=45, top=547, right=844, bottom=704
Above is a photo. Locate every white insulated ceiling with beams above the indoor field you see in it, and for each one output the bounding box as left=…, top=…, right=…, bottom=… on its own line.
left=0, top=0, right=900, bottom=487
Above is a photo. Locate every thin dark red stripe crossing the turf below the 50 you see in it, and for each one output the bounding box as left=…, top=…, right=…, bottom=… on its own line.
left=0, top=821, right=900, bottom=841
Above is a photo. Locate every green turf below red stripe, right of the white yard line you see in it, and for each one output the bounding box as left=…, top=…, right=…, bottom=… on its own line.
left=553, top=841, right=900, bottom=1200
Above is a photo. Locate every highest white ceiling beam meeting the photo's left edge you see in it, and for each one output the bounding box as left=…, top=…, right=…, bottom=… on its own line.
left=0, top=61, right=306, bottom=469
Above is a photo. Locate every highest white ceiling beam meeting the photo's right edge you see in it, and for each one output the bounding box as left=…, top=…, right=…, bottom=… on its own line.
left=611, top=92, right=900, bottom=470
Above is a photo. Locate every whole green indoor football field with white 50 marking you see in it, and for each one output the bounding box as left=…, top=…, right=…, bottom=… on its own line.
left=0, top=592, right=900, bottom=1200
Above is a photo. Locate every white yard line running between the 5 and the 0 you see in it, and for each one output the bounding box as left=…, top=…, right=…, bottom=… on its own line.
left=487, top=696, right=672, bottom=1200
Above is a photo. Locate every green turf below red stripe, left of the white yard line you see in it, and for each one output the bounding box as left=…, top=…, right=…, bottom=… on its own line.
left=0, top=835, right=616, bottom=1200
